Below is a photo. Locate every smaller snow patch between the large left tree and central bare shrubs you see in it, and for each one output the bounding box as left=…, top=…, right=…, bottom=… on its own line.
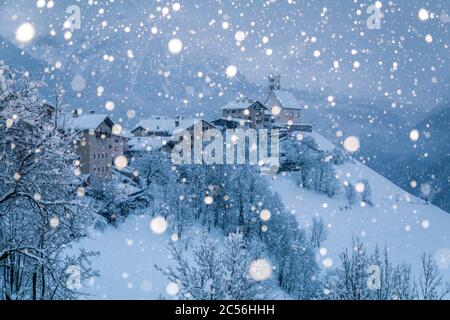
left=80, top=215, right=170, bottom=300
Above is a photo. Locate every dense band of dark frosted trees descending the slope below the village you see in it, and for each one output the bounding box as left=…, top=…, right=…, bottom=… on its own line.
left=133, top=152, right=320, bottom=299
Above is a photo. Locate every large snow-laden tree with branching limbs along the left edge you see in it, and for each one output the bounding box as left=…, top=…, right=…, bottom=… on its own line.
left=0, top=66, right=95, bottom=300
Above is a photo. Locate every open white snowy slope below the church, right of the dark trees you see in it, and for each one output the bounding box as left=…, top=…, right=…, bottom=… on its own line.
left=271, top=133, right=450, bottom=277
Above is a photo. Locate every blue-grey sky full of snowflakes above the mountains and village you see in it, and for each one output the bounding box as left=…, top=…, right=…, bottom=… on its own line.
left=0, top=0, right=450, bottom=109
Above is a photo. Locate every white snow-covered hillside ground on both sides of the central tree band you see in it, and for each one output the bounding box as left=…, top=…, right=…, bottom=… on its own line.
left=76, top=132, right=450, bottom=299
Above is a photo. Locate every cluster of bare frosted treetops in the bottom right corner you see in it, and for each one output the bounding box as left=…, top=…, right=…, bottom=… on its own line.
left=324, top=238, right=450, bottom=300
